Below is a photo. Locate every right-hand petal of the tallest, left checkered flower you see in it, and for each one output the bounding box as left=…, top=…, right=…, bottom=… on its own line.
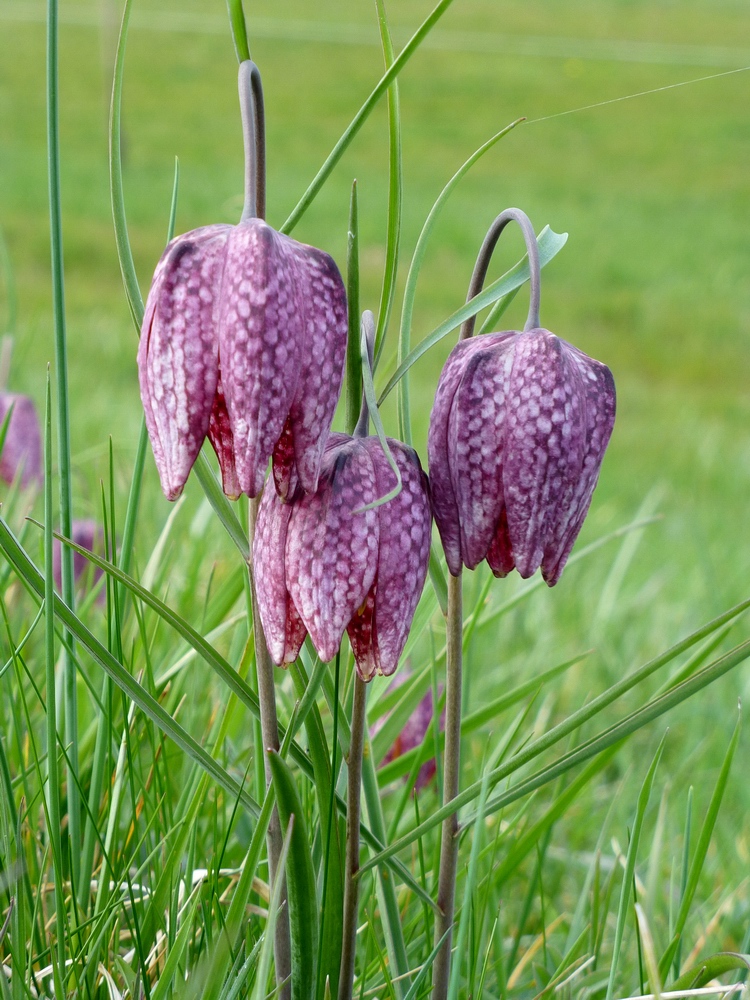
left=290, top=243, right=348, bottom=493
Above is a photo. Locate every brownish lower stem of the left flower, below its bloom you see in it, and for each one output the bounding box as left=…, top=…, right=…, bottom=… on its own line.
left=248, top=497, right=292, bottom=1000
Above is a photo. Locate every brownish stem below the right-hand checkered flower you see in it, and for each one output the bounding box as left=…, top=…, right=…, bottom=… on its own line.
left=432, top=573, right=463, bottom=1000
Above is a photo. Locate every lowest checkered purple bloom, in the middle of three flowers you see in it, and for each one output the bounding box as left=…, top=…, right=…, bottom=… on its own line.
left=253, top=434, right=431, bottom=681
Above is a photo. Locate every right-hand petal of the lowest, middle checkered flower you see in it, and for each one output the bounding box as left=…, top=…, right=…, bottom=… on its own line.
left=362, top=437, right=432, bottom=680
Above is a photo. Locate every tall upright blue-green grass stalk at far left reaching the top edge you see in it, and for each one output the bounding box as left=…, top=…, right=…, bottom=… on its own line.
left=47, top=0, right=81, bottom=885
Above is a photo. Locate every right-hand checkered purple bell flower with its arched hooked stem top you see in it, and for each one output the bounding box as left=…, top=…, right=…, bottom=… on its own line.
left=428, top=209, right=615, bottom=586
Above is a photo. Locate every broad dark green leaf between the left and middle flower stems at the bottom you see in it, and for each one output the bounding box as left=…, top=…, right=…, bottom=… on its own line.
left=268, top=750, right=318, bottom=1000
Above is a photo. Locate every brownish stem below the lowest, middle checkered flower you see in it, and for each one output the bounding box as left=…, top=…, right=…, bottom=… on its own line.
left=338, top=674, right=367, bottom=1000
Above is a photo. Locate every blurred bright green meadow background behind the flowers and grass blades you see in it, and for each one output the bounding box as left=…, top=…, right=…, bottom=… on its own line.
left=0, top=0, right=750, bottom=988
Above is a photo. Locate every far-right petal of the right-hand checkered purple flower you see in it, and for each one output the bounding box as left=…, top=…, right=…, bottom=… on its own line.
left=542, top=341, right=616, bottom=587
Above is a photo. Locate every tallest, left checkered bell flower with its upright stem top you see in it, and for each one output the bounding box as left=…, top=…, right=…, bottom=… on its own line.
left=138, top=63, right=347, bottom=500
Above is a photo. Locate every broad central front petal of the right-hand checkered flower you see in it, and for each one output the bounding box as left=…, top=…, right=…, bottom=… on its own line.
left=503, top=329, right=585, bottom=579
